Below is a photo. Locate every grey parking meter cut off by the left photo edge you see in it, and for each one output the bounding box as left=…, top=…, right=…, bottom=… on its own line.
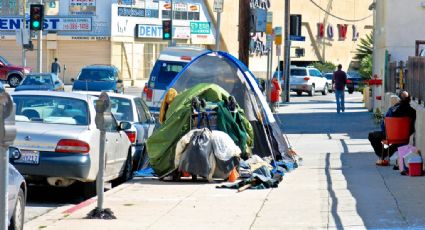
left=0, top=91, right=16, bottom=230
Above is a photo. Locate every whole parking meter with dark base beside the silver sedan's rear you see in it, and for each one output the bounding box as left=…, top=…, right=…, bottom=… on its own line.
left=87, top=92, right=116, bottom=219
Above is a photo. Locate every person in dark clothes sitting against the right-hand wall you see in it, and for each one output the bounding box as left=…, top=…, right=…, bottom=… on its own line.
left=368, top=91, right=416, bottom=165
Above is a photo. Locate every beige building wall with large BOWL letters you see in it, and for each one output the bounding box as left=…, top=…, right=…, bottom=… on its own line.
left=207, top=0, right=373, bottom=77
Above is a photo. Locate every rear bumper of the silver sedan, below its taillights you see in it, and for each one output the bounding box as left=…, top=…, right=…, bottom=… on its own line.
left=11, top=152, right=91, bottom=181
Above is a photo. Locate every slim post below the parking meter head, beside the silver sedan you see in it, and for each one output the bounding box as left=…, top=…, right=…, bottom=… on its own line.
left=96, top=129, right=106, bottom=210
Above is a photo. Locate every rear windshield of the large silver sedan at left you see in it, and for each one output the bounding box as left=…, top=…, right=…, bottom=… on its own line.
left=13, top=95, right=89, bottom=125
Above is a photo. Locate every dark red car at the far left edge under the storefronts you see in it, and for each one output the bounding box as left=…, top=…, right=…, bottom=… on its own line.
left=0, top=56, right=31, bottom=88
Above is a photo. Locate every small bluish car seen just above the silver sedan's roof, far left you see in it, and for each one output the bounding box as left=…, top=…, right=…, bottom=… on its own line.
left=15, top=73, right=65, bottom=91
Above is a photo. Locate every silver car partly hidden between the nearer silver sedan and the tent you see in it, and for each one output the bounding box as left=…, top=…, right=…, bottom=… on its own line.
left=81, top=92, right=156, bottom=171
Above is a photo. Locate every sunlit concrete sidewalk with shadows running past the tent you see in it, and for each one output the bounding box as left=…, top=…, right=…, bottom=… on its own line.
left=25, top=94, right=425, bottom=229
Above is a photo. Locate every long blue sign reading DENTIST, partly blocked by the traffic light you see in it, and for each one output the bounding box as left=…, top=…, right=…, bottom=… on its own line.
left=0, top=17, right=92, bottom=31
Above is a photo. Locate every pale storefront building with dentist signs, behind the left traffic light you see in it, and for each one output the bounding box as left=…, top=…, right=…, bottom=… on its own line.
left=0, top=0, right=215, bottom=85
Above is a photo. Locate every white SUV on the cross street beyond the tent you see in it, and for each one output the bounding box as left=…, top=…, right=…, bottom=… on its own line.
left=289, top=66, right=331, bottom=96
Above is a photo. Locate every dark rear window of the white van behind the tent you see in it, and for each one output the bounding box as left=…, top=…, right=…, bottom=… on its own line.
left=149, top=61, right=187, bottom=89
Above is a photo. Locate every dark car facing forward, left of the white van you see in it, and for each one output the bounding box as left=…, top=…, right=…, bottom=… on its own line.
left=71, top=65, right=124, bottom=93
